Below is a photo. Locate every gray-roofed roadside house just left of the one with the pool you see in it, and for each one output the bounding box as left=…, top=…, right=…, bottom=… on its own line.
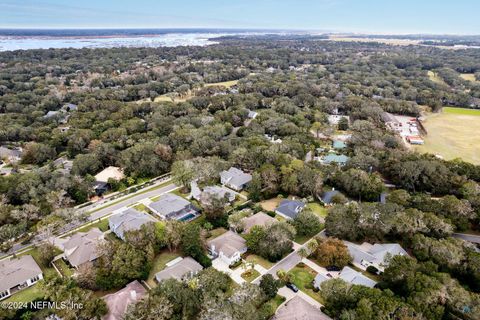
left=108, top=208, right=155, bottom=240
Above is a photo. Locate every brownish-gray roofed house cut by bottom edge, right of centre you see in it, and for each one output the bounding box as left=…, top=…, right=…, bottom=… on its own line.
left=272, top=295, right=331, bottom=320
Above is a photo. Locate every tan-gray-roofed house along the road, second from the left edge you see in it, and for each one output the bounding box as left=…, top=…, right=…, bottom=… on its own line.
left=63, top=228, right=104, bottom=268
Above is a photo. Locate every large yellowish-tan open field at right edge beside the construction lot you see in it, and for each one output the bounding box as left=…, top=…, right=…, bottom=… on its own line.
left=414, top=108, right=480, bottom=164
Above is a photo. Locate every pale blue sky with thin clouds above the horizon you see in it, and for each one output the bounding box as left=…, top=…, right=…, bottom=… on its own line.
left=0, top=0, right=480, bottom=35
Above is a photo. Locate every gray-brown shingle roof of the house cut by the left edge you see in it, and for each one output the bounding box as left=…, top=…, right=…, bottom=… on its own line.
left=0, top=255, right=42, bottom=292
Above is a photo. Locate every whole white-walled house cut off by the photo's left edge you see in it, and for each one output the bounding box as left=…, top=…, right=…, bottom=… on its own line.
left=0, top=255, right=43, bottom=300
